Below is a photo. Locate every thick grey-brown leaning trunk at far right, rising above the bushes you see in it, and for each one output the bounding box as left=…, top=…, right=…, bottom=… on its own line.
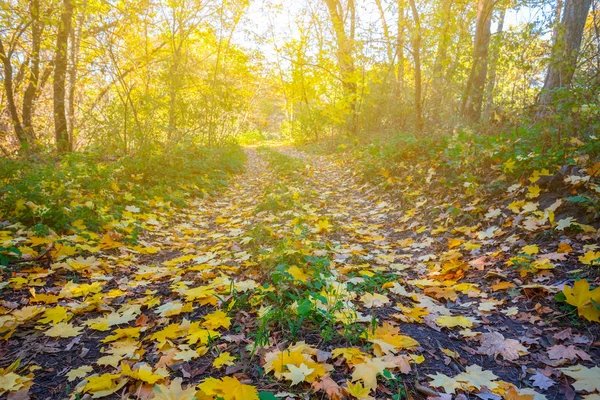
left=539, top=0, right=592, bottom=106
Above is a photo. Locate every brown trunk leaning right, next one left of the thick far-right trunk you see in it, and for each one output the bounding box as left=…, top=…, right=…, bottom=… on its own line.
left=461, top=0, right=494, bottom=122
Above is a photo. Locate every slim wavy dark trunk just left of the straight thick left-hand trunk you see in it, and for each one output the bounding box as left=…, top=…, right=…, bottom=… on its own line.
left=22, top=0, right=44, bottom=144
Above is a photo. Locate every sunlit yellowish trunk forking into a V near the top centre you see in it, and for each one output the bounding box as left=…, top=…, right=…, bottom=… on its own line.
left=325, top=0, right=358, bottom=134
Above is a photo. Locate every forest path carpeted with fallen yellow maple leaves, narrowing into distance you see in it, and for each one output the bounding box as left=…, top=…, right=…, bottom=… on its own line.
left=0, top=147, right=600, bottom=400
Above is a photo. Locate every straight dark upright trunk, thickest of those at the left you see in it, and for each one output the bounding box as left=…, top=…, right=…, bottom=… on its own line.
left=54, top=0, right=73, bottom=153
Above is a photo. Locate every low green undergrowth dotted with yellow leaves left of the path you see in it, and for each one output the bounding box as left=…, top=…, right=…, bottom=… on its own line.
left=0, top=146, right=244, bottom=236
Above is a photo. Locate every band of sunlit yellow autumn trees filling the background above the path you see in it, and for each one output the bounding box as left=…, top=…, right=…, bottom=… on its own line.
left=0, top=0, right=600, bottom=154
